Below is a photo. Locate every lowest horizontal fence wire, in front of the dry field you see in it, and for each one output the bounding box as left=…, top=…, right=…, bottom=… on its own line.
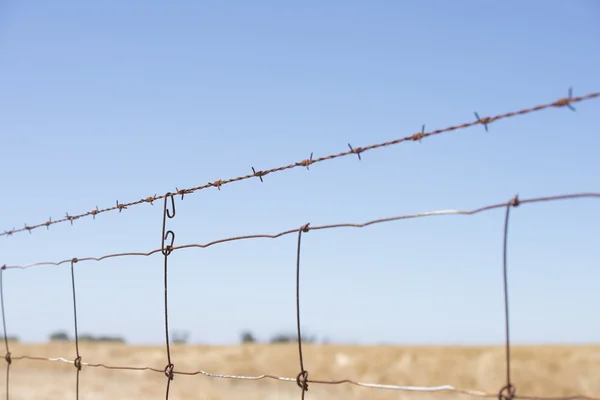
left=5, top=356, right=600, bottom=400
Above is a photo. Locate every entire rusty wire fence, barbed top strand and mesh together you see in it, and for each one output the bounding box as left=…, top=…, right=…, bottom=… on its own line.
left=0, top=90, right=600, bottom=400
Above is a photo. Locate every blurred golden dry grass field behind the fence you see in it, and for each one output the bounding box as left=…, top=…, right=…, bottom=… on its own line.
left=0, top=343, right=600, bottom=400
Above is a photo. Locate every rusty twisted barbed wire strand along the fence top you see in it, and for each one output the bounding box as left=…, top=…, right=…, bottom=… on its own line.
left=0, top=89, right=600, bottom=237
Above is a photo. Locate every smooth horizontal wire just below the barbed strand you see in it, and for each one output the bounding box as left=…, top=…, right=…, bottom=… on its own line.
left=4, top=192, right=600, bottom=269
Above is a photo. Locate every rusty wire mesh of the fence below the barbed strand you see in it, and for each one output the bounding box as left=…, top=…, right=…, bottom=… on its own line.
left=0, top=192, right=600, bottom=400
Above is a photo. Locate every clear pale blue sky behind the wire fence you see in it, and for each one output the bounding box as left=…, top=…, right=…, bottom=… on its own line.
left=0, top=0, right=600, bottom=344
